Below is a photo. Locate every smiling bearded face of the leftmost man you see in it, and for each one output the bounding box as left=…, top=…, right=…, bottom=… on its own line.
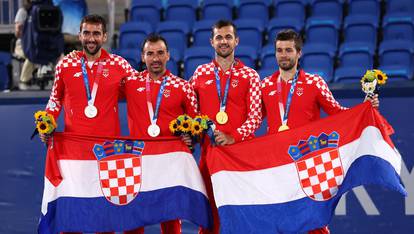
left=79, top=23, right=107, bottom=56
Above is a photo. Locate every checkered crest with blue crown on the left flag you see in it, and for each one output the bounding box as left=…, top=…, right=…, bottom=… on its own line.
left=93, top=140, right=144, bottom=205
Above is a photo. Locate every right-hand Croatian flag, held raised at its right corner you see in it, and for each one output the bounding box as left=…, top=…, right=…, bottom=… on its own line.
left=207, top=103, right=406, bottom=234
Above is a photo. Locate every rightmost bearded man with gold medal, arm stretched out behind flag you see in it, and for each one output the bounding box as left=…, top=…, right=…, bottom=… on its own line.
left=262, top=29, right=379, bottom=234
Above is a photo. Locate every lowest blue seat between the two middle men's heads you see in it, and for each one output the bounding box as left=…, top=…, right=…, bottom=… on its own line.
left=183, top=46, right=214, bottom=80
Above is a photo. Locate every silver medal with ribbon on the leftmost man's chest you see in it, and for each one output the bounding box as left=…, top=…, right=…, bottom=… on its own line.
left=81, top=58, right=103, bottom=119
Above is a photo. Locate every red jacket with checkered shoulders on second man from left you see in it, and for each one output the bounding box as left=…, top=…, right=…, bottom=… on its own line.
left=125, top=70, right=197, bottom=138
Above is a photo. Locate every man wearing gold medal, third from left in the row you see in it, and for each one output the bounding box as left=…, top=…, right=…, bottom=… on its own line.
left=190, top=20, right=261, bottom=233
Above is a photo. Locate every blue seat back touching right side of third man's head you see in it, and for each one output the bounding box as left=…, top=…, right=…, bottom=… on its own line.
left=234, top=19, right=264, bottom=53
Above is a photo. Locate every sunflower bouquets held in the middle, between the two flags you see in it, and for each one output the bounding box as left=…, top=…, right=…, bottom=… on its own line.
left=169, top=114, right=215, bottom=142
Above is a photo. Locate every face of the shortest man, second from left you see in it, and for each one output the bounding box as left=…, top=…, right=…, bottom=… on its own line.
left=141, top=40, right=170, bottom=75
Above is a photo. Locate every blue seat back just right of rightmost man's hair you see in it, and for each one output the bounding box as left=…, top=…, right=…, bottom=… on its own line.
left=305, top=17, right=339, bottom=48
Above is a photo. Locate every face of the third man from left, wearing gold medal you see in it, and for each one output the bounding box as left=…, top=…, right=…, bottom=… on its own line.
left=210, top=26, right=239, bottom=58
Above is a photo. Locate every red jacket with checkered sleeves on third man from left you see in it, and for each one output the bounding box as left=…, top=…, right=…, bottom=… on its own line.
left=190, top=60, right=262, bottom=142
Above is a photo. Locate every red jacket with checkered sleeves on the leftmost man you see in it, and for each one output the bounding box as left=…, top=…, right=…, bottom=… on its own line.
left=46, top=49, right=135, bottom=136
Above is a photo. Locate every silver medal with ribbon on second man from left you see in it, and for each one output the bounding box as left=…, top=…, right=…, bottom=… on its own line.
left=145, top=74, right=168, bottom=137
